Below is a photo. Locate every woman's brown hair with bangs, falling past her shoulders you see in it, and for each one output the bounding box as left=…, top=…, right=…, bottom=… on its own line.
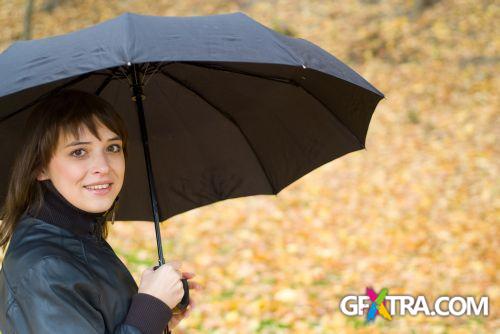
left=0, top=89, right=128, bottom=250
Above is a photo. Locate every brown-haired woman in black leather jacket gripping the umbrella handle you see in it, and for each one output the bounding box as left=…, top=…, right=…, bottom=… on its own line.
left=0, top=90, right=200, bottom=334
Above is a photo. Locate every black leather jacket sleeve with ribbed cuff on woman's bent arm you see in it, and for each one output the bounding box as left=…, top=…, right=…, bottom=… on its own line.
left=7, top=257, right=171, bottom=334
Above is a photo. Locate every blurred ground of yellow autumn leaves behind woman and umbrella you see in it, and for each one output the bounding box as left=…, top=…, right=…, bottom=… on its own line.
left=0, top=0, right=500, bottom=333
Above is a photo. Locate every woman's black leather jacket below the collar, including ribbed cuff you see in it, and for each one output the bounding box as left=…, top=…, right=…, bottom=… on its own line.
left=0, top=213, right=172, bottom=334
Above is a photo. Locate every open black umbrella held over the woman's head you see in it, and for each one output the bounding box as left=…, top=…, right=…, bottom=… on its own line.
left=0, top=13, right=384, bottom=312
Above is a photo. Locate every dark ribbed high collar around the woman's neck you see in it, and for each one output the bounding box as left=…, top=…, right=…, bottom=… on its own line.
left=28, top=180, right=106, bottom=236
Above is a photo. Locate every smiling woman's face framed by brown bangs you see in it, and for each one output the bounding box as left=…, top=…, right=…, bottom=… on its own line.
left=37, top=122, right=125, bottom=213
